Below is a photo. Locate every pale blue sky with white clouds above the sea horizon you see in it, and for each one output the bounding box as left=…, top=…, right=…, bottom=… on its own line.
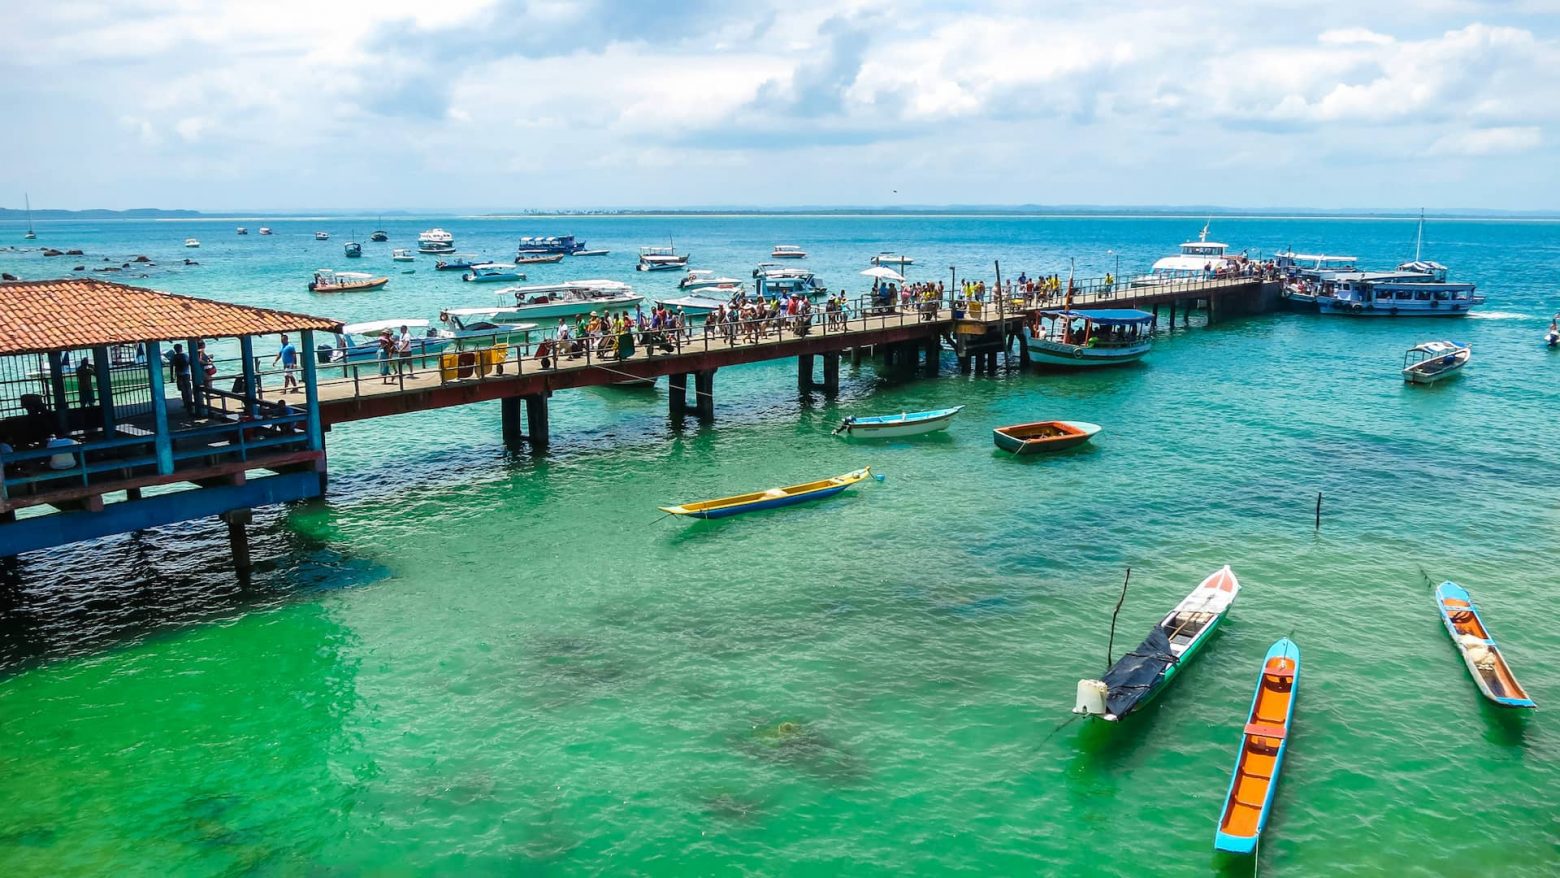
left=0, top=0, right=1560, bottom=211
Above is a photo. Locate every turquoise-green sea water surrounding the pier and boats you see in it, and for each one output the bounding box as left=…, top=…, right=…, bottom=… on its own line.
left=0, top=217, right=1560, bottom=875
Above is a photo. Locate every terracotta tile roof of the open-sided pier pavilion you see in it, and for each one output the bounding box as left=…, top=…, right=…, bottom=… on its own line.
left=0, top=278, right=342, bottom=356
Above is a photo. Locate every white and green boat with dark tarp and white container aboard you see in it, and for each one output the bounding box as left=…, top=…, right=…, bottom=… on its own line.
left=1073, top=565, right=1240, bottom=722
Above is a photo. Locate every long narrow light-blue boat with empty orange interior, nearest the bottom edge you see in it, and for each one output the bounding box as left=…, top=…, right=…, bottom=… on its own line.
left=1214, top=638, right=1299, bottom=853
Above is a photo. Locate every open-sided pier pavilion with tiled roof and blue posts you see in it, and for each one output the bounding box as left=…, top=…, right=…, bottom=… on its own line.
left=0, top=279, right=340, bottom=568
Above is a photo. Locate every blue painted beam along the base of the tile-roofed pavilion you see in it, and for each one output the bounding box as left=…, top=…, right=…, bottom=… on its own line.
left=0, top=473, right=321, bottom=557
